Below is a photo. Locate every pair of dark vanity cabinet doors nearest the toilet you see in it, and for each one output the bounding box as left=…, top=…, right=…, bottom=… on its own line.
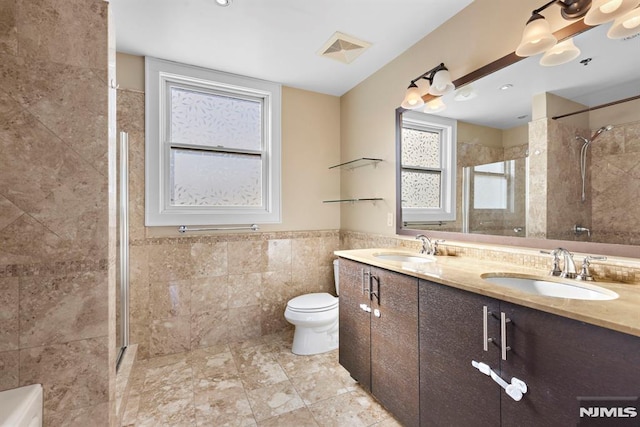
left=339, top=259, right=420, bottom=426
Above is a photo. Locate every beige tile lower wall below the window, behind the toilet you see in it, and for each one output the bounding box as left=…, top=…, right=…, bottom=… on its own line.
left=130, top=230, right=339, bottom=358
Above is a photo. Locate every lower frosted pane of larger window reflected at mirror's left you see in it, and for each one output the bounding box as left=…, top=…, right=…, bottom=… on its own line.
left=402, top=171, right=440, bottom=208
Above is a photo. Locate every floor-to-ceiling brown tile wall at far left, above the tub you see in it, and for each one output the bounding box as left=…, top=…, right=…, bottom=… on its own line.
left=0, top=0, right=113, bottom=426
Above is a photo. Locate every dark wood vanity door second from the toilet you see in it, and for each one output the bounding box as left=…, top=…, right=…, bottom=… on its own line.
left=371, top=267, right=420, bottom=426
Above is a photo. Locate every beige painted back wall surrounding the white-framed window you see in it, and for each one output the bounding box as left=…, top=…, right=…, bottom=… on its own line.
left=117, top=53, right=340, bottom=237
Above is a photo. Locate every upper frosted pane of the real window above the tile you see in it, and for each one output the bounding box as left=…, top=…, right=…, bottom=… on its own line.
left=170, top=87, right=262, bottom=151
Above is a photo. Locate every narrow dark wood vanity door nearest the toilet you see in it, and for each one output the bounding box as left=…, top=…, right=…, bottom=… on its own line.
left=338, top=258, right=371, bottom=390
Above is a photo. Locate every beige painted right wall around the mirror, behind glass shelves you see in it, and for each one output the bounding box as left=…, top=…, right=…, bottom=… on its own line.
left=340, top=0, right=567, bottom=234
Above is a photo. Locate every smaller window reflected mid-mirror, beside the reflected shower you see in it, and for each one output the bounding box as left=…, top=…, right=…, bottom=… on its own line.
left=473, top=160, right=514, bottom=210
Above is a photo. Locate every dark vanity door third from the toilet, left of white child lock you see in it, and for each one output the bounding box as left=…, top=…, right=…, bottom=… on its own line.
left=419, top=280, right=502, bottom=427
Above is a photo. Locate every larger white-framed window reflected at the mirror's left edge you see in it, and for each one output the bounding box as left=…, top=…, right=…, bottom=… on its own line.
left=399, top=111, right=456, bottom=222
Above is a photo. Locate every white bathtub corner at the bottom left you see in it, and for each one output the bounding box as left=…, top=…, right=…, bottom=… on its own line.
left=0, top=384, right=42, bottom=427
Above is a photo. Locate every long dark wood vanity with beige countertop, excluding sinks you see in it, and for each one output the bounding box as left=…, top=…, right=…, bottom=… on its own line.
left=336, top=249, right=640, bottom=426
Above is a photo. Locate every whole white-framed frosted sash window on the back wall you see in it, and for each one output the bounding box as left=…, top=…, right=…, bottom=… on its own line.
left=145, top=58, right=281, bottom=226
